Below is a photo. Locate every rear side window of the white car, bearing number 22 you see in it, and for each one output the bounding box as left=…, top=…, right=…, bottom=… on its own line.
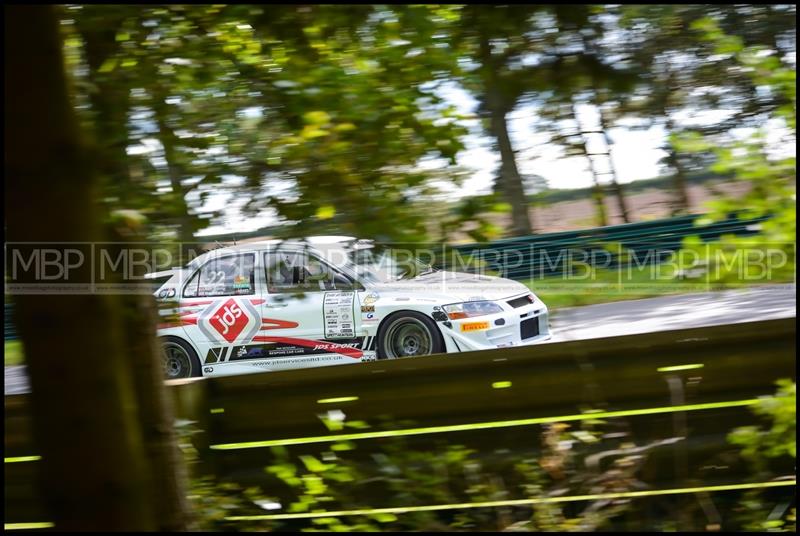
left=183, top=253, right=256, bottom=298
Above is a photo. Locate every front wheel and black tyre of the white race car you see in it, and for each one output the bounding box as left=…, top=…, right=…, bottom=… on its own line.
left=378, top=311, right=444, bottom=359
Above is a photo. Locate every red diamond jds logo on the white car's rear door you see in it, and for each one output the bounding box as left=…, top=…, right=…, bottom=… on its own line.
left=197, top=298, right=261, bottom=343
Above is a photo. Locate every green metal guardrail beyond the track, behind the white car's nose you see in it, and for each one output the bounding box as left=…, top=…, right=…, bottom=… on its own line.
left=442, top=214, right=769, bottom=280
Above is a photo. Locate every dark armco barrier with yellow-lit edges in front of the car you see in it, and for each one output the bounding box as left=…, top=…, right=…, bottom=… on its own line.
left=5, top=318, right=796, bottom=523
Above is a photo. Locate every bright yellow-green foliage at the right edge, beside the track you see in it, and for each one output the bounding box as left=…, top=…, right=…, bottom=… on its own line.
left=676, top=18, right=797, bottom=285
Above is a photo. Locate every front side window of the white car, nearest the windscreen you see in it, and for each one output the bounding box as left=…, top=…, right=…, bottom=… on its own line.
left=264, top=251, right=352, bottom=293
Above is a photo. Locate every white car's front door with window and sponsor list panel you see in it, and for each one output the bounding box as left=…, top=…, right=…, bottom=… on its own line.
left=258, top=249, right=362, bottom=366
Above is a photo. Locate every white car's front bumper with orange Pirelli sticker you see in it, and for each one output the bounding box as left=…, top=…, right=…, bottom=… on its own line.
left=438, top=298, right=552, bottom=352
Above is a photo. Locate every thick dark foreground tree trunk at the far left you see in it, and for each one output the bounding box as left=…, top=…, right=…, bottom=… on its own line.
left=5, top=5, right=157, bottom=531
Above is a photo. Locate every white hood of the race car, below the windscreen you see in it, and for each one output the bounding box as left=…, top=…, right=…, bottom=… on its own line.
left=369, top=271, right=531, bottom=303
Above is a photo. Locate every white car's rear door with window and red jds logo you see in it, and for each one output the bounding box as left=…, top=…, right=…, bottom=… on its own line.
left=179, top=252, right=263, bottom=366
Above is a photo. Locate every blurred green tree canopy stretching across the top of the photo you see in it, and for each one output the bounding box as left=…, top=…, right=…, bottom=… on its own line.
left=62, top=5, right=794, bottom=245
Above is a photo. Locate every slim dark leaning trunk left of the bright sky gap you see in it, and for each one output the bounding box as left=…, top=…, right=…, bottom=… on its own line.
left=480, top=30, right=533, bottom=236
